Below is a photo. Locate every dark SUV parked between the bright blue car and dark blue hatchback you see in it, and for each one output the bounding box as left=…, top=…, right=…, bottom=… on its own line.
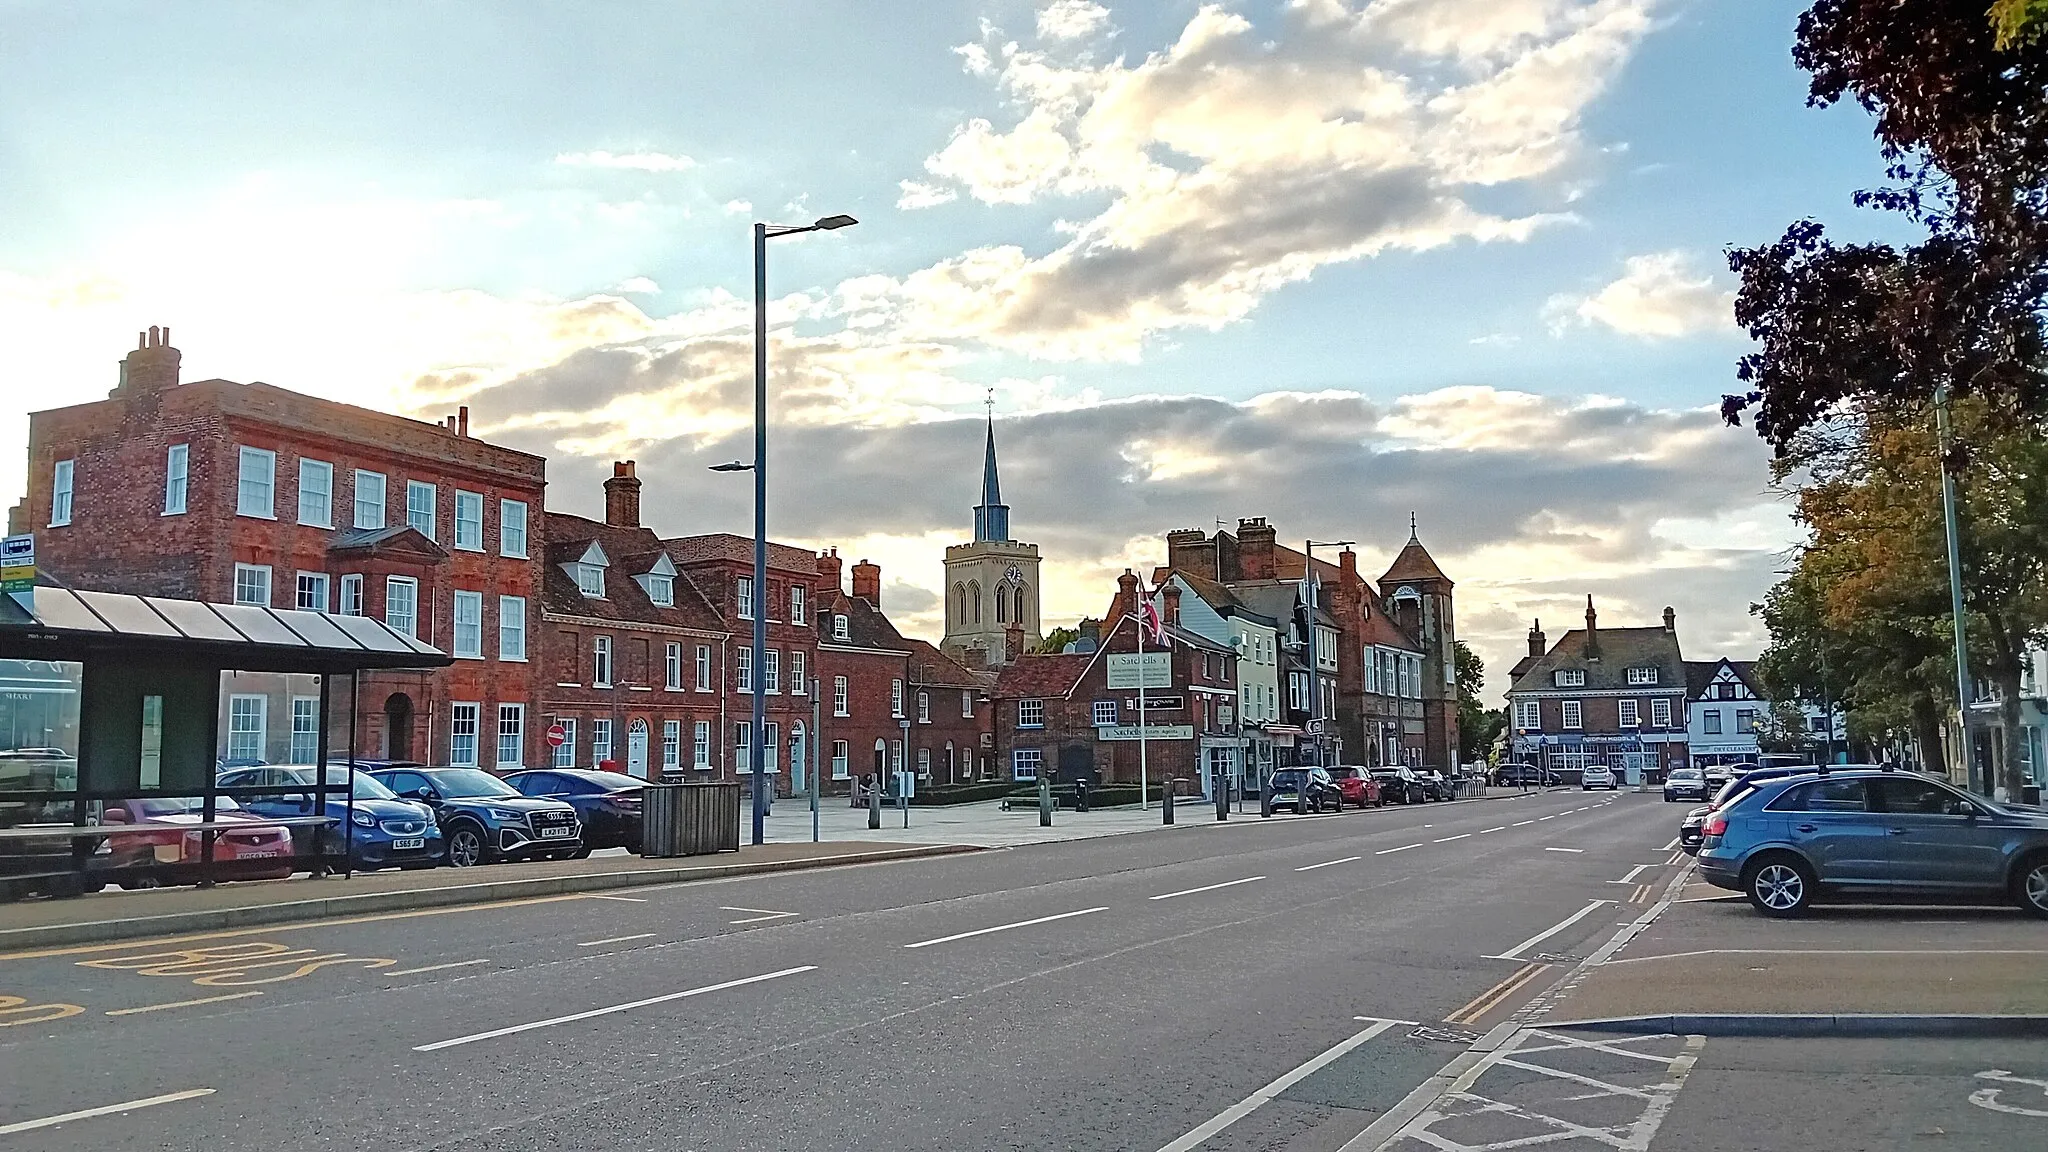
left=371, top=769, right=590, bottom=867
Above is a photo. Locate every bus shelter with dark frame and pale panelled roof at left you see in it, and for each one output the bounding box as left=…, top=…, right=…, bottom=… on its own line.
left=0, top=586, right=451, bottom=900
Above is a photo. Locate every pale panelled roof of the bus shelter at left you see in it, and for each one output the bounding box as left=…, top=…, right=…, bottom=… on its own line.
left=0, top=586, right=451, bottom=672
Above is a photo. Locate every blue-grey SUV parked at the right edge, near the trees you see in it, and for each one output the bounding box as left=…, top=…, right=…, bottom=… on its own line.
left=1700, top=769, right=2048, bottom=918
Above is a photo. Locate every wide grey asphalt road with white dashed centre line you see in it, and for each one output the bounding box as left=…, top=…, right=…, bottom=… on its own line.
left=0, top=791, right=1679, bottom=1152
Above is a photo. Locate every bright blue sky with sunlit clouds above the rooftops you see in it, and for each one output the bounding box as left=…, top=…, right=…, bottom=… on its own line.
left=0, top=0, right=1916, bottom=699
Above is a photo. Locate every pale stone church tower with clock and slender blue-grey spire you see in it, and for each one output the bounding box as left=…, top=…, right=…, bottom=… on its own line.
left=940, top=410, right=1040, bottom=668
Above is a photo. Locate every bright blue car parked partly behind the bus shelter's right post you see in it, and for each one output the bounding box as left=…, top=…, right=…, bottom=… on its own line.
left=217, top=765, right=446, bottom=871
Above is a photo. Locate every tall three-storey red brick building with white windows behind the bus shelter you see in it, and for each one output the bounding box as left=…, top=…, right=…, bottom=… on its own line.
left=10, top=328, right=545, bottom=769
